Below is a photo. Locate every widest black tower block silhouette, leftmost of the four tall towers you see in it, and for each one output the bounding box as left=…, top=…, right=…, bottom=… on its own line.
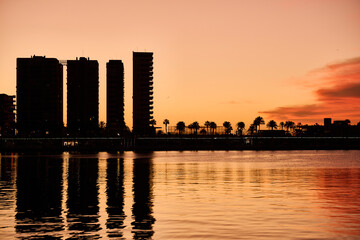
left=16, top=56, right=63, bottom=136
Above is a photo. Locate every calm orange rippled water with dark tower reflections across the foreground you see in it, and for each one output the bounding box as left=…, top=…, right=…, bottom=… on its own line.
left=0, top=151, right=360, bottom=239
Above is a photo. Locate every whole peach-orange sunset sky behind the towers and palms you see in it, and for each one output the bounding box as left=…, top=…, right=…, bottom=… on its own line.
left=0, top=0, right=360, bottom=131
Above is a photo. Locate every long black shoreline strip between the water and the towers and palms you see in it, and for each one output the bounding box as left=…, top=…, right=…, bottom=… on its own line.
left=0, top=136, right=360, bottom=153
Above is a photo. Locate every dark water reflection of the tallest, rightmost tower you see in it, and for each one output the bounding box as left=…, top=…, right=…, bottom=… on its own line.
left=131, top=158, right=155, bottom=239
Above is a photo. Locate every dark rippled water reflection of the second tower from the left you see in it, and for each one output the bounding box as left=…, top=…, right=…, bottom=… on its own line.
left=67, top=158, right=100, bottom=238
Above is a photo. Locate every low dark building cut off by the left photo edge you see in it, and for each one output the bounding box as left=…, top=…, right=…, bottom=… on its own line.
left=0, top=94, right=15, bottom=137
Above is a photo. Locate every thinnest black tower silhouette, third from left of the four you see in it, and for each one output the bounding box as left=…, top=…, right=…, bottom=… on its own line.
left=106, top=60, right=125, bottom=134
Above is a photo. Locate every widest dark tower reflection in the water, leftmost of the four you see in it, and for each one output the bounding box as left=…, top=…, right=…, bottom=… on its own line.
left=15, top=157, right=64, bottom=238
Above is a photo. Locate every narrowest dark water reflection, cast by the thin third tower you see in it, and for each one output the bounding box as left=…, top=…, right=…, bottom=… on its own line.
left=106, top=158, right=126, bottom=238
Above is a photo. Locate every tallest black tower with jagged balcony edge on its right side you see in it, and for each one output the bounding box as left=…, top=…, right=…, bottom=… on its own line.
left=133, top=52, right=154, bottom=135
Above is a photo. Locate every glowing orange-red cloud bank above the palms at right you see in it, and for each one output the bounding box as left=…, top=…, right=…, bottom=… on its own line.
left=260, top=57, right=360, bottom=123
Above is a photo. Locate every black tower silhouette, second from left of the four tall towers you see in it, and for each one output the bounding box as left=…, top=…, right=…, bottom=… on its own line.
left=67, top=57, right=99, bottom=136
